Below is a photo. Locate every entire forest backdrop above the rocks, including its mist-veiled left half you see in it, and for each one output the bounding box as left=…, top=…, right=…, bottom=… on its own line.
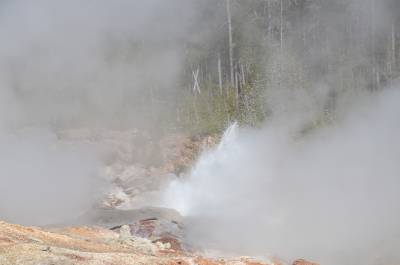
left=2, top=0, right=400, bottom=134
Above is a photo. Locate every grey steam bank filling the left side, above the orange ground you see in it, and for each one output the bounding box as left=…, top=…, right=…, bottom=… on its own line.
left=0, top=0, right=193, bottom=225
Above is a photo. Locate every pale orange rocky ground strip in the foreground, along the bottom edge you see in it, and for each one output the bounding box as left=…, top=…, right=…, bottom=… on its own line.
left=0, top=217, right=317, bottom=265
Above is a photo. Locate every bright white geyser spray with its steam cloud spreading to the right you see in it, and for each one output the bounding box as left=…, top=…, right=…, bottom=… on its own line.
left=164, top=86, right=400, bottom=264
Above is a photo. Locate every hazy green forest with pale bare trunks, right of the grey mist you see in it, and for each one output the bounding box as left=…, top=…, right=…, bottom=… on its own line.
left=167, top=0, right=400, bottom=132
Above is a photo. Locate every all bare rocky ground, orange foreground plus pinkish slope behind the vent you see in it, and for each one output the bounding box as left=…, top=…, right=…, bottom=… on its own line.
left=0, top=130, right=316, bottom=265
